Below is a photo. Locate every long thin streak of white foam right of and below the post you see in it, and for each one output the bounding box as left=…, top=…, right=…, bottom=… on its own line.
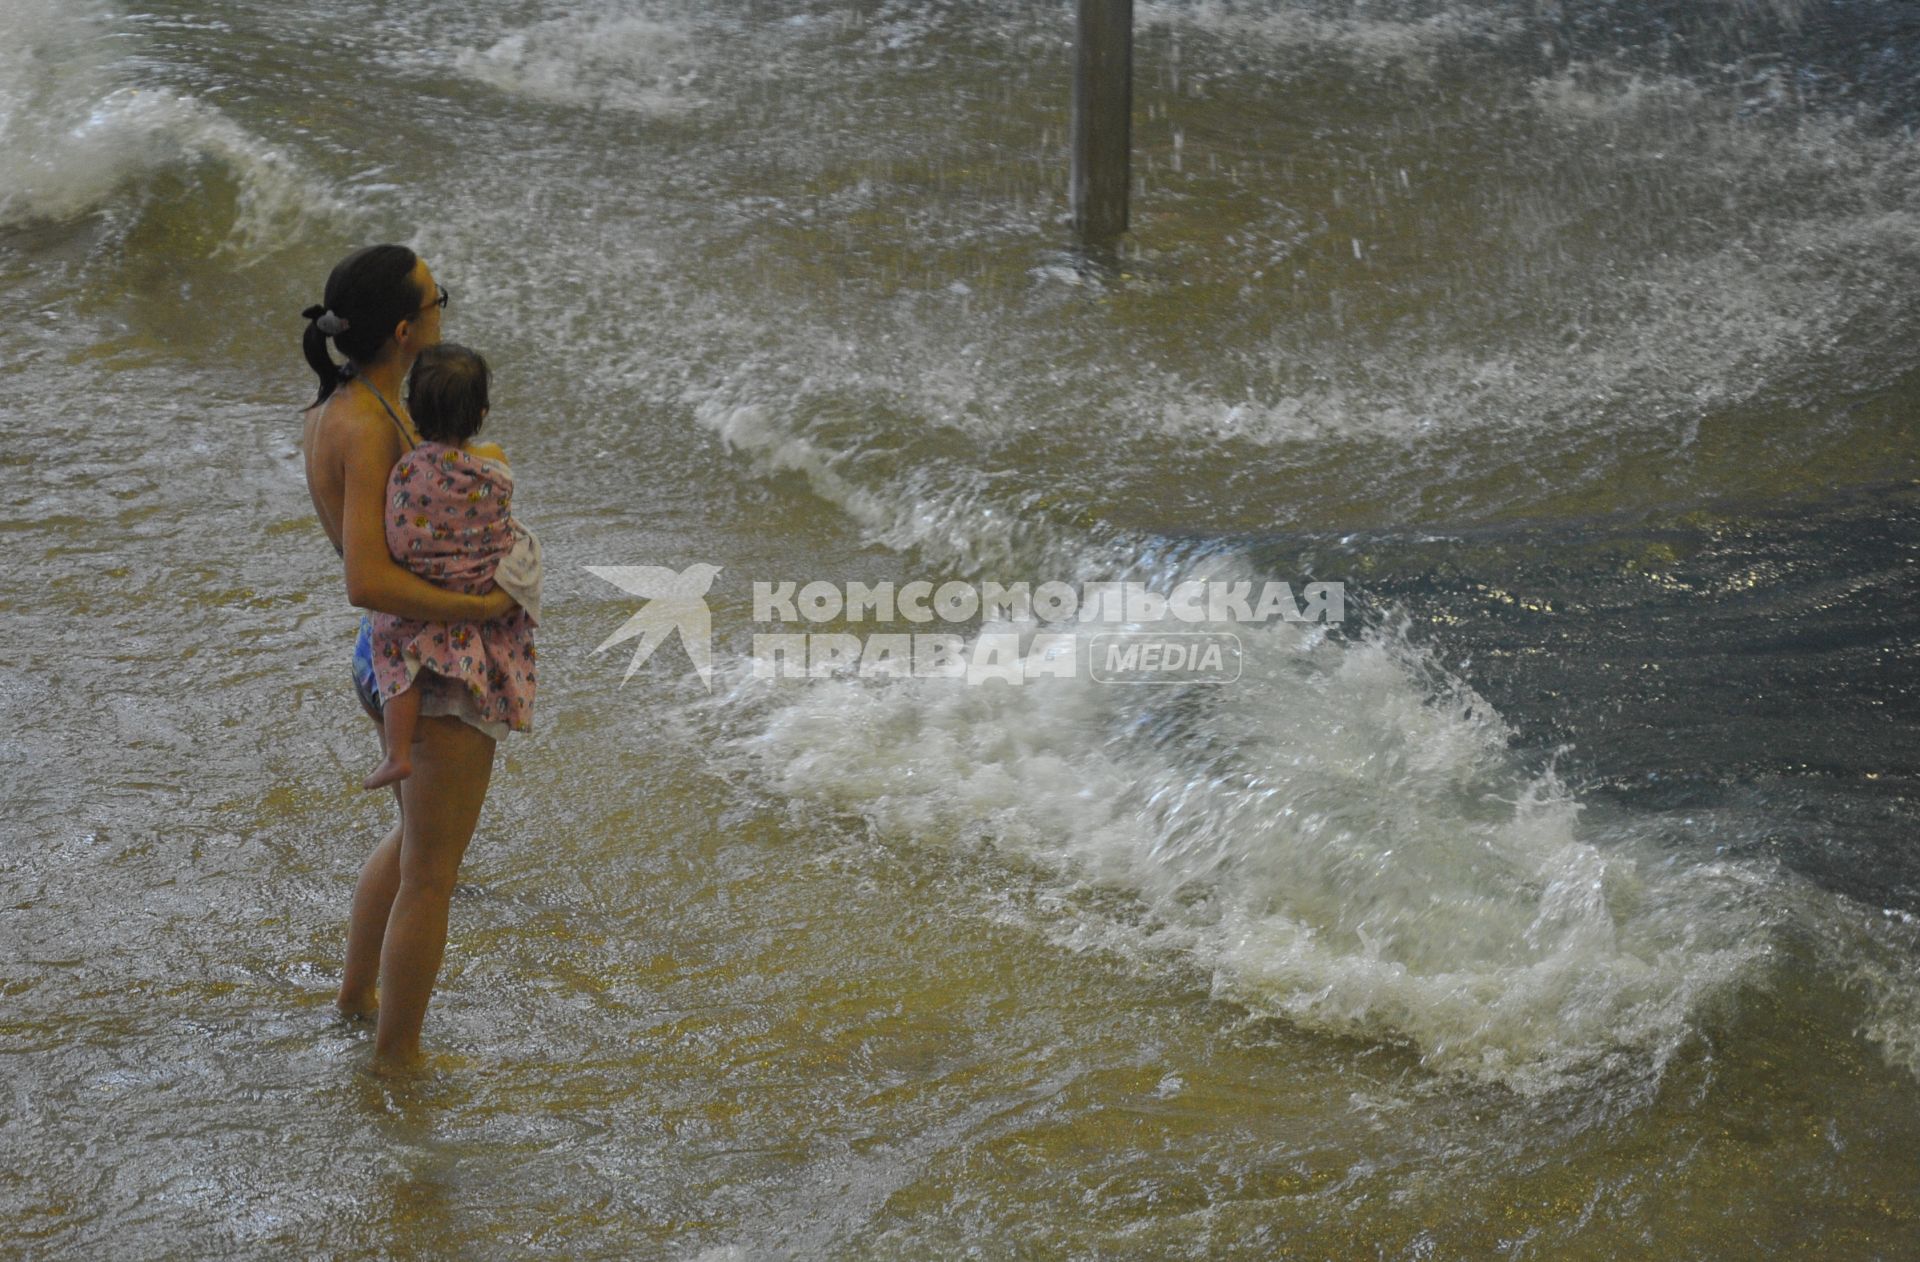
left=1137, top=211, right=1920, bottom=448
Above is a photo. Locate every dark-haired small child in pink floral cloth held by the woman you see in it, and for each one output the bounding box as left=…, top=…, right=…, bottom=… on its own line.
left=363, top=342, right=540, bottom=789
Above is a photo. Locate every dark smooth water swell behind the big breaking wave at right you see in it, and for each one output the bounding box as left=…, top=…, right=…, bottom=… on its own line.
left=1315, top=484, right=1920, bottom=912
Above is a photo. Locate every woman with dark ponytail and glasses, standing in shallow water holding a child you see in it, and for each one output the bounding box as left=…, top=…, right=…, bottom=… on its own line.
left=301, top=246, right=515, bottom=1068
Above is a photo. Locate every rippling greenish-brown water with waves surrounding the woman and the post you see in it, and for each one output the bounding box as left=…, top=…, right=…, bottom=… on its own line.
left=0, top=0, right=1920, bottom=1258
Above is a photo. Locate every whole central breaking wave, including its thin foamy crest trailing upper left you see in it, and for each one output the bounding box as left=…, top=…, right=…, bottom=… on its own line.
left=695, top=378, right=1920, bottom=1099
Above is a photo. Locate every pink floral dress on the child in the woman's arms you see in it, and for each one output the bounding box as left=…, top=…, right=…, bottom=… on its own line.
left=372, top=442, right=534, bottom=738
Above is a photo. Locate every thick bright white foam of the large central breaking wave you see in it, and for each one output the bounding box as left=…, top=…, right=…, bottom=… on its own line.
left=710, top=603, right=1797, bottom=1089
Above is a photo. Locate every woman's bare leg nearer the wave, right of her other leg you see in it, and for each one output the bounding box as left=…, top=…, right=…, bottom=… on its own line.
left=374, top=715, right=493, bottom=1066
